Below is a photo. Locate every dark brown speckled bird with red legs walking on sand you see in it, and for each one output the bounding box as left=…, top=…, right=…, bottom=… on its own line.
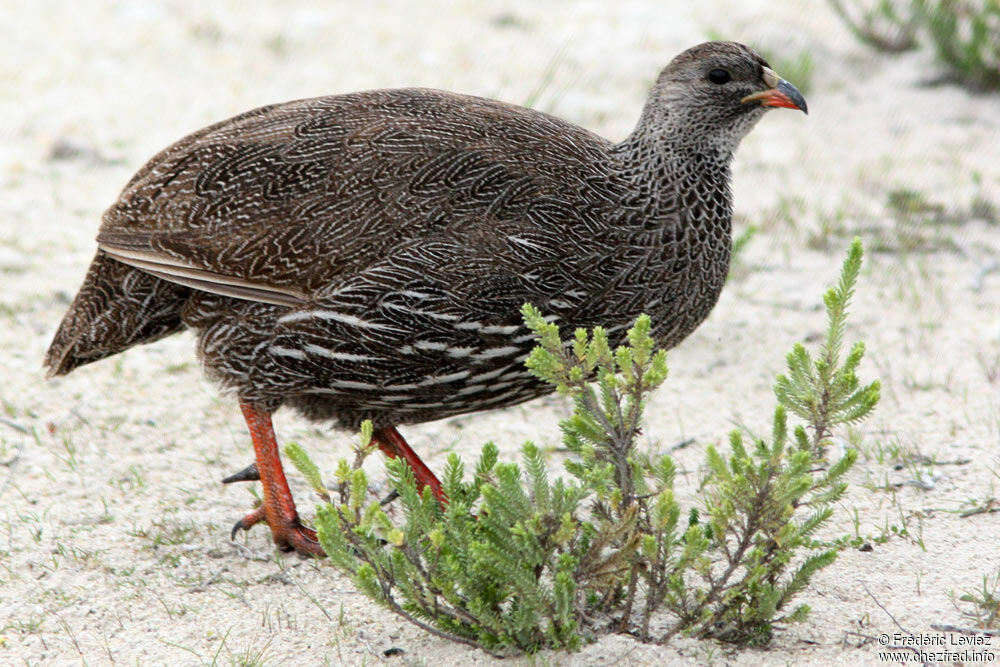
left=44, top=41, right=807, bottom=556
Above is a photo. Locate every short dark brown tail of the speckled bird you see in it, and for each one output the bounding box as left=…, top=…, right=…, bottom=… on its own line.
left=44, top=250, right=191, bottom=377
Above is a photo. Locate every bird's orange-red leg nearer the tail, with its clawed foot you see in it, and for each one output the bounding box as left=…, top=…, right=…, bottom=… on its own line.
left=233, top=401, right=325, bottom=556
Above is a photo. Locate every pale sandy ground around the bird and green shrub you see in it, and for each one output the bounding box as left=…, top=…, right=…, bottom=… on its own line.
left=0, top=0, right=1000, bottom=665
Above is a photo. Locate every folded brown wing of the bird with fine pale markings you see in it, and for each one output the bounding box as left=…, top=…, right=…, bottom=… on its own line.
left=97, top=89, right=620, bottom=306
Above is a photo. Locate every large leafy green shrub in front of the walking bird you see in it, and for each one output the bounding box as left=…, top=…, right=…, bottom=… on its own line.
left=300, top=240, right=878, bottom=652
